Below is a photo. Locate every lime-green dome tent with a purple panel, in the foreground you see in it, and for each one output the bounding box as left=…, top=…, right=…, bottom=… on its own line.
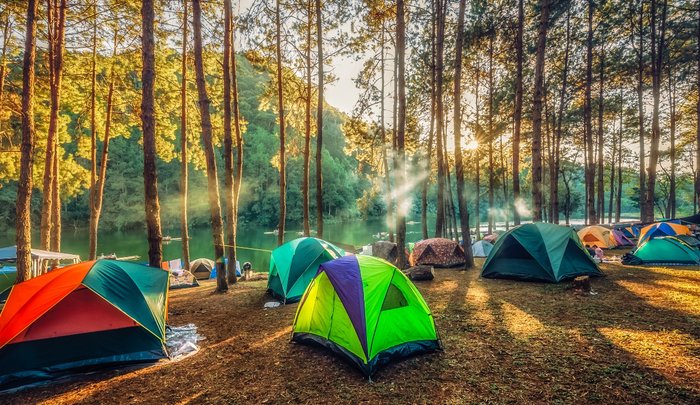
left=292, top=256, right=442, bottom=377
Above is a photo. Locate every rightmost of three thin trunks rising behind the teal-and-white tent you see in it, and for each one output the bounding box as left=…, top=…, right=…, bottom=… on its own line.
left=316, top=0, right=324, bottom=238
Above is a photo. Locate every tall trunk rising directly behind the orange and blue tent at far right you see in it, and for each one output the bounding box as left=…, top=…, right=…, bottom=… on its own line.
left=644, top=0, right=668, bottom=222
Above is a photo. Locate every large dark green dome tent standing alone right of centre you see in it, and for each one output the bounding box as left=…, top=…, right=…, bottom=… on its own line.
left=481, top=222, right=603, bottom=283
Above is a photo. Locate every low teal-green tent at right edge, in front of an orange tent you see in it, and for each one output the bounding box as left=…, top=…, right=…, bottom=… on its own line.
left=624, top=236, right=700, bottom=266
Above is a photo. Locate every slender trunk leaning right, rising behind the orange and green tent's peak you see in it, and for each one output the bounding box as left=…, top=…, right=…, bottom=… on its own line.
left=90, top=30, right=119, bottom=260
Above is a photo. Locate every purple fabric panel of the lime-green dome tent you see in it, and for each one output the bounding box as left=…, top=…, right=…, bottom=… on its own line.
left=318, top=256, right=368, bottom=356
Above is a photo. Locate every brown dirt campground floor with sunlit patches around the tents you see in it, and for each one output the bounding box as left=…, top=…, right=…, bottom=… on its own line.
left=0, top=263, right=700, bottom=404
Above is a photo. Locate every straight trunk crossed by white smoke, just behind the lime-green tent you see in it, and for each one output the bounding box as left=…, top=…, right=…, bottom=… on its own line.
left=396, top=0, right=407, bottom=269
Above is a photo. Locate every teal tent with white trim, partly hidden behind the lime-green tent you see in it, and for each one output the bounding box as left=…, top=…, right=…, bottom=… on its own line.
left=267, top=237, right=345, bottom=303
